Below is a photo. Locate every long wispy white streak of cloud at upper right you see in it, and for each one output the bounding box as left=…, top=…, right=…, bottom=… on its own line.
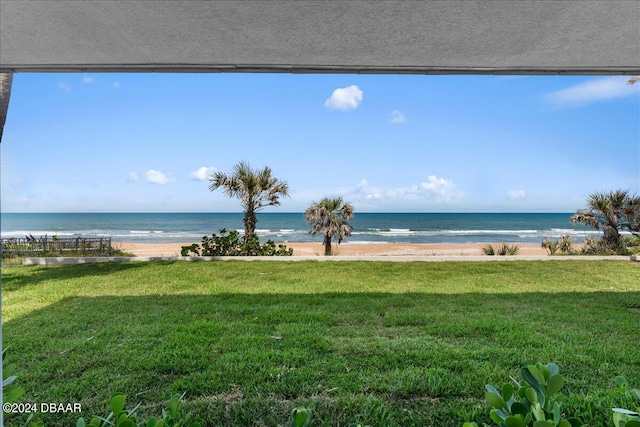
left=546, top=76, right=640, bottom=106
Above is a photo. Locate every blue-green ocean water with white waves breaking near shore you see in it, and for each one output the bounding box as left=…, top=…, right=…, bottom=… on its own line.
left=0, top=213, right=598, bottom=244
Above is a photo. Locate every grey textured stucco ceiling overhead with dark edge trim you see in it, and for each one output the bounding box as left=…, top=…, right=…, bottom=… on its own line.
left=0, top=0, right=640, bottom=74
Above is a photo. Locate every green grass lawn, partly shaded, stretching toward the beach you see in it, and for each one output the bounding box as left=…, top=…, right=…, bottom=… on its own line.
left=2, top=261, right=640, bottom=426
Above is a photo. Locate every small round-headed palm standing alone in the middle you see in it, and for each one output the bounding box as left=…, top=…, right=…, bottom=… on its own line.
left=304, top=197, right=353, bottom=255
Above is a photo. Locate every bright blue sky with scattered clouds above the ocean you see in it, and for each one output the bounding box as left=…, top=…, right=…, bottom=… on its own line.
left=0, top=73, right=640, bottom=212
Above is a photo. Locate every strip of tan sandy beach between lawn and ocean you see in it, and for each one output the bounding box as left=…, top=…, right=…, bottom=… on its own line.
left=113, top=242, right=547, bottom=257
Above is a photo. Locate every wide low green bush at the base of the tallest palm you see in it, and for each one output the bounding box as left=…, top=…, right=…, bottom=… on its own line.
left=180, top=228, right=293, bottom=256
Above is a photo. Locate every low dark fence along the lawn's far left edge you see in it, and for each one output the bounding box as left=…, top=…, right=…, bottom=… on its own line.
left=2, top=236, right=112, bottom=257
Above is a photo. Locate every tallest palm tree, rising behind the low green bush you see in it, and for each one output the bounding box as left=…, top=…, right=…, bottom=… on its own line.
left=209, top=162, right=289, bottom=242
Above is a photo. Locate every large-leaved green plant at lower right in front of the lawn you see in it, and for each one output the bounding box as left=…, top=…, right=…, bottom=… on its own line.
left=463, top=363, right=584, bottom=427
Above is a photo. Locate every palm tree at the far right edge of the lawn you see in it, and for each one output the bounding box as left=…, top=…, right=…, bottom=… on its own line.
left=571, top=190, right=632, bottom=249
